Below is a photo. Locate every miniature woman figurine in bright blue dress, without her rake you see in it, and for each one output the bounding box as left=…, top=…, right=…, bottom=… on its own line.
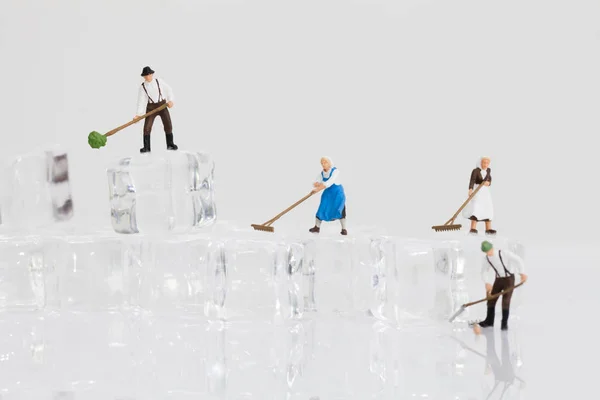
left=309, top=157, right=348, bottom=235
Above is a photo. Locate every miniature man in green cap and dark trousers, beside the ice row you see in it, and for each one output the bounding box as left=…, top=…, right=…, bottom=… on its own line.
left=479, top=240, right=527, bottom=331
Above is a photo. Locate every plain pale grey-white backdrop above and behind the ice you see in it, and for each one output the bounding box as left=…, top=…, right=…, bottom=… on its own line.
left=0, top=0, right=600, bottom=240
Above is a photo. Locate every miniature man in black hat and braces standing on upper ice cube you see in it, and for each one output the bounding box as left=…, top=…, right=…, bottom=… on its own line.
left=133, top=67, right=177, bottom=153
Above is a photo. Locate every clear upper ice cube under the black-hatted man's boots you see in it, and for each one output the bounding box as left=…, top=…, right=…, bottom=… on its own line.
left=108, top=151, right=217, bottom=233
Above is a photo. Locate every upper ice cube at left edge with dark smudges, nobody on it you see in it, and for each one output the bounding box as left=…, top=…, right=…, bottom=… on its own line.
left=0, top=149, right=73, bottom=229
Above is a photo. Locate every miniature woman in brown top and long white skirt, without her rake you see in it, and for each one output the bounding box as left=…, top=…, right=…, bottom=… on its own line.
left=462, top=157, right=496, bottom=235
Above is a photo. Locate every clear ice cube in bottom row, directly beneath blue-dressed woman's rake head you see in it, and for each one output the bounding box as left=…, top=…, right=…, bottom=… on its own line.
left=205, top=239, right=304, bottom=320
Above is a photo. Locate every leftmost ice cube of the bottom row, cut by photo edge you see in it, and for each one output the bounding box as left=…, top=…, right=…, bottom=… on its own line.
left=0, top=237, right=45, bottom=311
